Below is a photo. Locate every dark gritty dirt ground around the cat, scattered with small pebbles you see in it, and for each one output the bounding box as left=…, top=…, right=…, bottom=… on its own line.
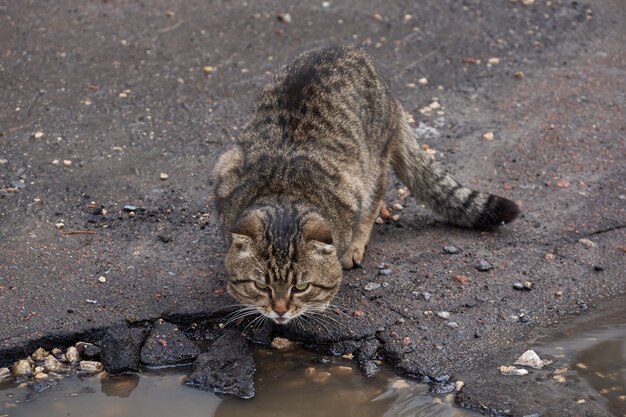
left=0, top=0, right=626, bottom=416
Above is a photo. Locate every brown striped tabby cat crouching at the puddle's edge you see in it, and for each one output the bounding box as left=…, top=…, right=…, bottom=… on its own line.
left=213, top=46, right=519, bottom=323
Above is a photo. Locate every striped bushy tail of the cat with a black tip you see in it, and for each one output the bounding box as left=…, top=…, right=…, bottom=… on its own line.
left=391, top=118, right=520, bottom=229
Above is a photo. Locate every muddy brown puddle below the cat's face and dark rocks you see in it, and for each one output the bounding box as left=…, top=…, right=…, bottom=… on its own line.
left=0, top=349, right=478, bottom=417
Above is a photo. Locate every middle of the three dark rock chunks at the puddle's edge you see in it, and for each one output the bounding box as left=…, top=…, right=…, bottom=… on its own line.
left=140, top=320, right=201, bottom=367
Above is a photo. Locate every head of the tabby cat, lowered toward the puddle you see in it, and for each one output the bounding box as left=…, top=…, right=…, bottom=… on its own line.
left=226, top=210, right=342, bottom=324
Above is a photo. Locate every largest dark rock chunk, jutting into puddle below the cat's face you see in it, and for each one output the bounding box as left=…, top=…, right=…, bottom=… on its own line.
left=185, top=331, right=256, bottom=398
